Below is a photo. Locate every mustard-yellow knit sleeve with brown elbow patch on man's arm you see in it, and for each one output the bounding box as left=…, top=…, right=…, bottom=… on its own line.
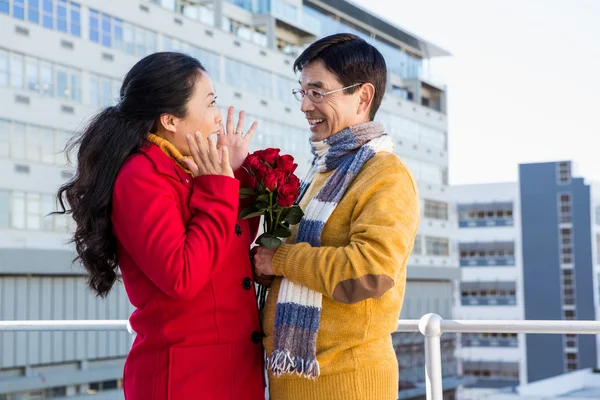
left=273, top=156, right=420, bottom=304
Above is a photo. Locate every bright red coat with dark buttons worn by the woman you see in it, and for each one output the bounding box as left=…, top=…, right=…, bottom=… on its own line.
left=112, top=145, right=264, bottom=400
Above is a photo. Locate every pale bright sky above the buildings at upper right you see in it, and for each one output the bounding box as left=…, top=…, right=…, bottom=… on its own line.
left=354, top=0, right=600, bottom=184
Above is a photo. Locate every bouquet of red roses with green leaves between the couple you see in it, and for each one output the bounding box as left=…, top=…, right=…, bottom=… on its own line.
left=240, top=148, right=304, bottom=249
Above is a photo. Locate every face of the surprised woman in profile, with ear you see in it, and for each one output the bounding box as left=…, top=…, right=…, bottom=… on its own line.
left=160, top=71, right=222, bottom=156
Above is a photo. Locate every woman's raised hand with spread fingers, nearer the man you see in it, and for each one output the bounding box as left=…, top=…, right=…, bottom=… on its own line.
left=217, top=107, right=258, bottom=171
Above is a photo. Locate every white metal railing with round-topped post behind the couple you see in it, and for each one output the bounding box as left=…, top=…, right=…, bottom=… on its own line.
left=0, top=314, right=600, bottom=400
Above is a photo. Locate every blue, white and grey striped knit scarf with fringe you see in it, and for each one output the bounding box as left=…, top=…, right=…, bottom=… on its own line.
left=267, top=122, right=394, bottom=379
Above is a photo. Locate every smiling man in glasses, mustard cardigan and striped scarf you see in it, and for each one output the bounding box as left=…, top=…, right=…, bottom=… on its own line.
left=254, top=34, right=419, bottom=400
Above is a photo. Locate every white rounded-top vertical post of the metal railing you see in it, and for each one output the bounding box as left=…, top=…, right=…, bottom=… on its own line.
left=419, top=314, right=444, bottom=400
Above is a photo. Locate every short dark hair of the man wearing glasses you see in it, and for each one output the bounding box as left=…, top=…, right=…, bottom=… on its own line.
left=294, top=33, right=387, bottom=121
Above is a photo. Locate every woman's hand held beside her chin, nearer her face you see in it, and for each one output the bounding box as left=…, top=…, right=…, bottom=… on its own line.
left=183, top=132, right=233, bottom=178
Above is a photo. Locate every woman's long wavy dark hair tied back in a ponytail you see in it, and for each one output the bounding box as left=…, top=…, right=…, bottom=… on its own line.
left=57, top=52, right=206, bottom=297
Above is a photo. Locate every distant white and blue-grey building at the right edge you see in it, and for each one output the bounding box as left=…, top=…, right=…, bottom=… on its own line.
left=452, top=161, right=600, bottom=399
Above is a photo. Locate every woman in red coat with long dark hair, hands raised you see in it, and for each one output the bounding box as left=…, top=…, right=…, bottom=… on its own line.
left=58, top=53, right=264, bottom=400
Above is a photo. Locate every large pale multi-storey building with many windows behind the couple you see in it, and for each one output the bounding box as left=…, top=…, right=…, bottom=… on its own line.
left=0, top=0, right=459, bottom=400
